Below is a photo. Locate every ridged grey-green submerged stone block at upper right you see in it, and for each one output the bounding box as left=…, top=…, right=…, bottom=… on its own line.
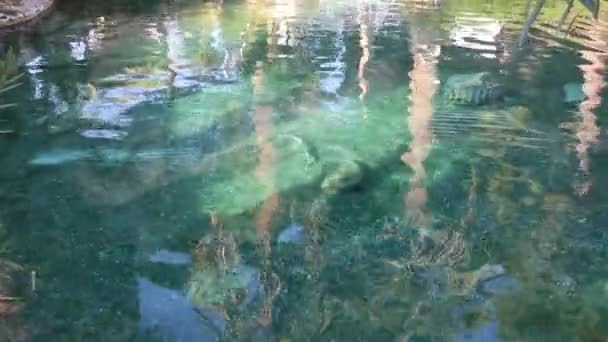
left=445, top=72, right=504, bottom=106
